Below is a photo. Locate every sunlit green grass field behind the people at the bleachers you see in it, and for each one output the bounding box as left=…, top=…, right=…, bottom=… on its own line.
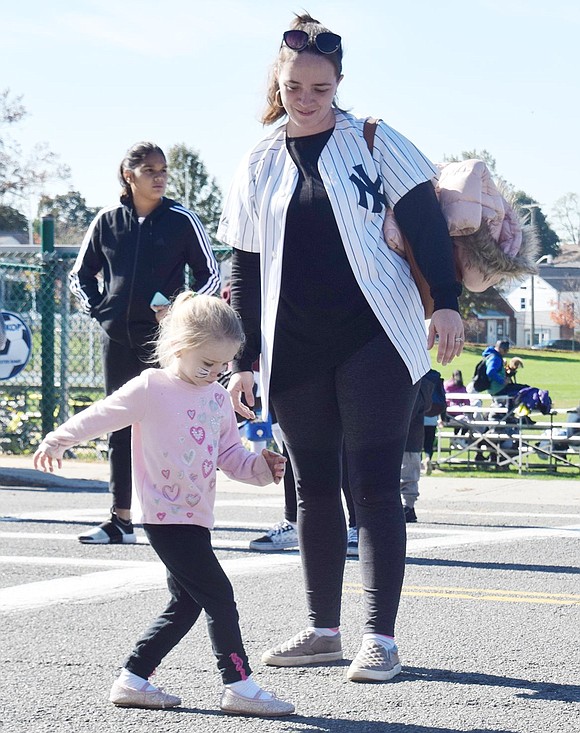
left=430, top=344, right=580, bottom=412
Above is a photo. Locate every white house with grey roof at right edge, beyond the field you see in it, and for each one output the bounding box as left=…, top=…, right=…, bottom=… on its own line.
left=505, top=262, right=580, bottom=346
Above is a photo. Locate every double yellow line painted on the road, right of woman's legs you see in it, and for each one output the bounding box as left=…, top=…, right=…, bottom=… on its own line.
left=344, top=583, right=580, bottom=606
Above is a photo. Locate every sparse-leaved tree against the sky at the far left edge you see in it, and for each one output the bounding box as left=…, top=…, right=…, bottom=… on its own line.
left=0, top=89, right=70, bottom=199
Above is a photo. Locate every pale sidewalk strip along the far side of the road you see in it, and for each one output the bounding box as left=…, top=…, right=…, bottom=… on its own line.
left=0, top=455, right=580, bottom=511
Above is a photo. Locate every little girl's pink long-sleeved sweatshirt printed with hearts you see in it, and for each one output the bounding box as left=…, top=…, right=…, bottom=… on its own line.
left=40, top=369, right=273, bottom=529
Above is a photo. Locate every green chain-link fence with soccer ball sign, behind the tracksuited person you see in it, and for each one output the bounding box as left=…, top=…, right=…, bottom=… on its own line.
left=0, top=221, right=230, bottom=453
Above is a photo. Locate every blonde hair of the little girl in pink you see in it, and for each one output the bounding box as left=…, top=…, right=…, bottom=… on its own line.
left=155, top=290, right=245, bottom=367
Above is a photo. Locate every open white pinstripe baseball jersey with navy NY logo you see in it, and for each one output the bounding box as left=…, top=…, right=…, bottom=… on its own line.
left=217, top=110, right=437, bottom=403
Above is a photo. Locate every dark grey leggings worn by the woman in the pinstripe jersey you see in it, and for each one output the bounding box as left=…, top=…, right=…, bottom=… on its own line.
left=271, top=334, right=418, bottom=636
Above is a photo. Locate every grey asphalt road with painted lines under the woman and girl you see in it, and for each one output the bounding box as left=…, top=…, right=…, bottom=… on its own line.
left=0, top=456, right=580, bottom=733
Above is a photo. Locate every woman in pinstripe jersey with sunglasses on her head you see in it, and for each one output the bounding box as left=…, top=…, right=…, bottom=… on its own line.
left=218, top=15, right=463, bottom=681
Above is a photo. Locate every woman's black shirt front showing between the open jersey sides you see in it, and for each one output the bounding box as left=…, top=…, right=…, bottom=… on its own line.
left=271, top=130, right=382, bottom=392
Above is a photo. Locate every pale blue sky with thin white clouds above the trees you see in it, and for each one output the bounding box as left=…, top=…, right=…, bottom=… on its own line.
left=0, top=0, right=580, bottom=232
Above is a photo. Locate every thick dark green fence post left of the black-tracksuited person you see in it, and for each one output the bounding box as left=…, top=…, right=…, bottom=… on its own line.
left=40, top=216, right=56, bottom=435
